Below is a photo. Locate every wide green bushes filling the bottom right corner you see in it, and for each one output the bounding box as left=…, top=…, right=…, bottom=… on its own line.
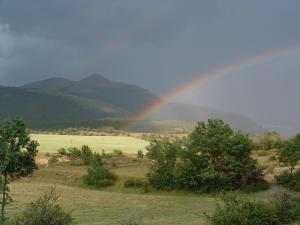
left=207, top=190, right=300, bottom=225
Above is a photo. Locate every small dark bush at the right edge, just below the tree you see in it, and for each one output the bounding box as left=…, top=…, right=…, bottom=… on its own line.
left=275, top=170, right=300, bottom=191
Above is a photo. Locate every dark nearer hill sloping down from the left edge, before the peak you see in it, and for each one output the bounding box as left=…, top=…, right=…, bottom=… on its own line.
left=0, top=86, right=123, bottom=127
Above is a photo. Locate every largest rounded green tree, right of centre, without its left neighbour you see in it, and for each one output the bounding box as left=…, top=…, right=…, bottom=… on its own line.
left=175, top=119, right=263, bottom=192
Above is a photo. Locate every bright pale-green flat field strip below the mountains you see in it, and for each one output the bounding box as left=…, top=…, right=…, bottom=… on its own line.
left=31, top=134, right=148, bottom=153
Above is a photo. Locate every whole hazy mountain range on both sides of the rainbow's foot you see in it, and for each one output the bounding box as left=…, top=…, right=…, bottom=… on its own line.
left=0, top=74, right=263, bottom=133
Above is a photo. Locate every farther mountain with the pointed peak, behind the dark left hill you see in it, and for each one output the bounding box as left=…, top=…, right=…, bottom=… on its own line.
left=23, top=74, right=157, bottom=113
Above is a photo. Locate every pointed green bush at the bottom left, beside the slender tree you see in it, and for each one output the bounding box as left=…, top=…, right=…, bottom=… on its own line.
left=8, top=189, right=74, bottom=225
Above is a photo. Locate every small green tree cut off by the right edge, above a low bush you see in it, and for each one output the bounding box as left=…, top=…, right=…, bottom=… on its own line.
left=279, top=134, right=300, bottom=174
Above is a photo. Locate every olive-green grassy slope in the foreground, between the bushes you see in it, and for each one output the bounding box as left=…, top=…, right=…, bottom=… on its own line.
left=8, top=162, right=270, bottom=225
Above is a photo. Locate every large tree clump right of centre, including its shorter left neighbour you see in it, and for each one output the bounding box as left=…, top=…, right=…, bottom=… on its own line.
left=147, top=120, right=268, bottom=192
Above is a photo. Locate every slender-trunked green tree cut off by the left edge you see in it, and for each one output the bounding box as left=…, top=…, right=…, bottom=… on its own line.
left=0, top=119, right=38, bottom=224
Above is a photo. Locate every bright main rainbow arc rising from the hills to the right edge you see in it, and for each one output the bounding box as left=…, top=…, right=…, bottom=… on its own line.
left=125, top=45, right=300, bottom=129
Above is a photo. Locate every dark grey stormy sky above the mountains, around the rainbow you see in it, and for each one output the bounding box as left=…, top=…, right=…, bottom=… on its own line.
left=0, top=0, right=300, bottom=135
